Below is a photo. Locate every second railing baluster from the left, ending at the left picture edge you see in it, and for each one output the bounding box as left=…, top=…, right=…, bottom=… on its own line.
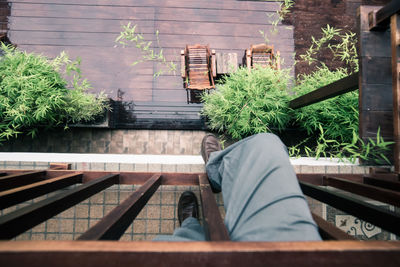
left=0, top=173, right=82, bottom=209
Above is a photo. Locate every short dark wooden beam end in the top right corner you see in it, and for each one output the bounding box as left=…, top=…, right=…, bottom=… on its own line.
left=368, top=0, right=400, bottom=31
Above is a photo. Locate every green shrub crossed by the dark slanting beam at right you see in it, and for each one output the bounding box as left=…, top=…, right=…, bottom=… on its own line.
left=293, top=66, right=358, bottom=142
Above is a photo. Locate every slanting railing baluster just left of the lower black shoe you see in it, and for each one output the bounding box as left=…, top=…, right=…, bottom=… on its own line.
left=78, top=174, right=161, bottom=240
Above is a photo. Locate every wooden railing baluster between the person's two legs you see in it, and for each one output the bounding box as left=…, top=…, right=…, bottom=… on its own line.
left=198, top=174, right=229, bottom=241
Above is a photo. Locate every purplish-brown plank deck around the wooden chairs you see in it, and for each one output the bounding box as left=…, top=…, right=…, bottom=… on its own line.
left=5, top=0, right=294, bottom=128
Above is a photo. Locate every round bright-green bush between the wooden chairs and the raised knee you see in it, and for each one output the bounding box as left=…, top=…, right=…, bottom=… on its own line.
left=202, top=67, right=290, bottom=138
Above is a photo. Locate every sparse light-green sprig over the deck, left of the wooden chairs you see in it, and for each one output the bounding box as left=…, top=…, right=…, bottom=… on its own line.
left=115, top=22, right=177, bottom=77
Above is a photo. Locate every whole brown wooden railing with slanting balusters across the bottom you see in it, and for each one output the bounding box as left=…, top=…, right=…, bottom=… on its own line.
left=0, top=169, right=400, bottom=267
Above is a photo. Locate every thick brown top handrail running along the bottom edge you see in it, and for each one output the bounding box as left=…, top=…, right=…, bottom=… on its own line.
left=0, top=241, right=400, bottom=267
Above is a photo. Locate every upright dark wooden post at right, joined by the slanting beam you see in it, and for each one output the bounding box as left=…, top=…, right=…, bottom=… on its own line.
left=358, top=6, right=393, bottom=164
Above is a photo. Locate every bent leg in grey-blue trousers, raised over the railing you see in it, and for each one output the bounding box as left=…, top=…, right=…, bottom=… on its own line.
left=206, top=134, right=320, bottom=241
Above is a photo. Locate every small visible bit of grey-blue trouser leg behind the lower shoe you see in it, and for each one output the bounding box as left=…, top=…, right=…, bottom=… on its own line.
left=154, top=217, right=205, bottom=241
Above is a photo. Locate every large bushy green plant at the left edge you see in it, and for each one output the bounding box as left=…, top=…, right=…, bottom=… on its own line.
left=0, top=44, right=107, bottom=140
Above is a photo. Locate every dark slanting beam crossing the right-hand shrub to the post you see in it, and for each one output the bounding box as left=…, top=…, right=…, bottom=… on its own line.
left=289, top=72, right=358, bottom=109
